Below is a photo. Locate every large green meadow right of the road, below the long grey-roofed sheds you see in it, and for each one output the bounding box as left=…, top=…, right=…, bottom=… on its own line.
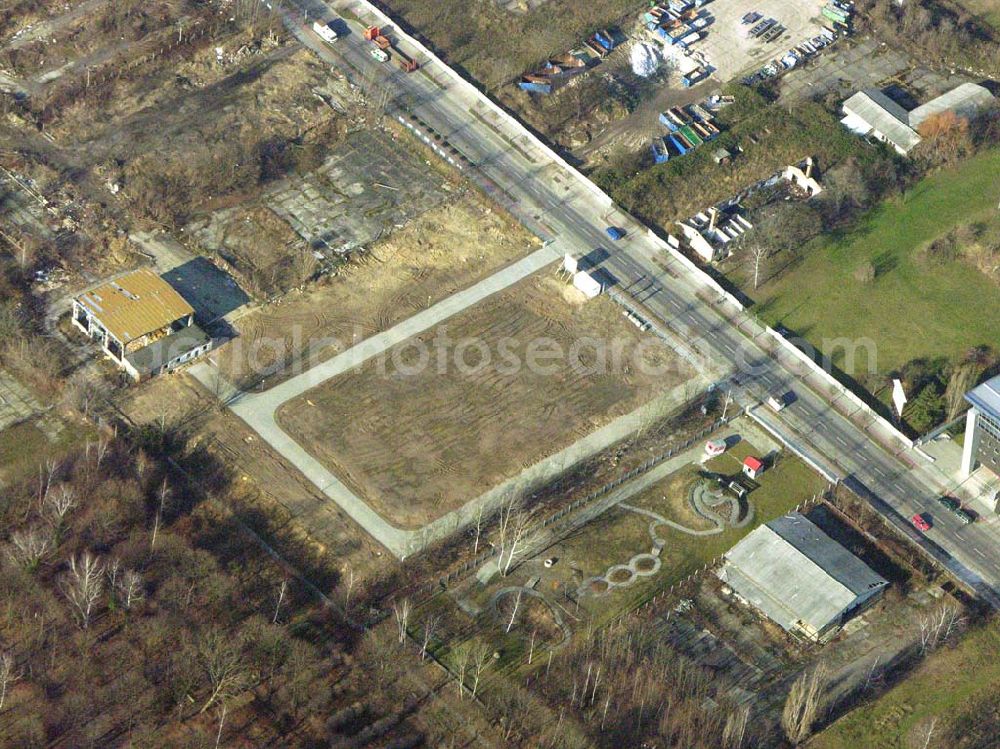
left=758, top=149, right=1000, bottom=376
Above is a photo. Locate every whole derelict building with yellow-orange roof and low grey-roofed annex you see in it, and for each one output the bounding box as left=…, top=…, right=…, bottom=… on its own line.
left=73, top=268, right=212, bottom=380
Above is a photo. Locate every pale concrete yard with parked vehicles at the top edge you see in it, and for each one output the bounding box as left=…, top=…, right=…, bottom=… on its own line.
left=693, top=0, right=823, bottom=81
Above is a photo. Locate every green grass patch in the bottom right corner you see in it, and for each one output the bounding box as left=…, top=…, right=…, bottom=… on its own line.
left=808, top=623, right=1000, bottom=749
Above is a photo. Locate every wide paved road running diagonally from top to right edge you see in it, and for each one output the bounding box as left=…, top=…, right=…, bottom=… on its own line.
left=262, top=0, right=1000, bottom=606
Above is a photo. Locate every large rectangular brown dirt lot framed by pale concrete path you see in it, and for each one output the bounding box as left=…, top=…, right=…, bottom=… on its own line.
left=278, top=275, right=691, bottom=527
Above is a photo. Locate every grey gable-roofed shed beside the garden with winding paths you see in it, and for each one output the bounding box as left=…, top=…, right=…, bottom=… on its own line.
left=717, top=513, right=889, bottom=640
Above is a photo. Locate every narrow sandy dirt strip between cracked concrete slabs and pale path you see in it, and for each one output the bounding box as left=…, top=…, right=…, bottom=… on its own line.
left=214, top=193, right=538, bottom=388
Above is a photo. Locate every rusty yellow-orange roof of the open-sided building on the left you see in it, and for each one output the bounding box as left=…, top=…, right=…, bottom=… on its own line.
left=77, top=268, right=194, bottom=343
